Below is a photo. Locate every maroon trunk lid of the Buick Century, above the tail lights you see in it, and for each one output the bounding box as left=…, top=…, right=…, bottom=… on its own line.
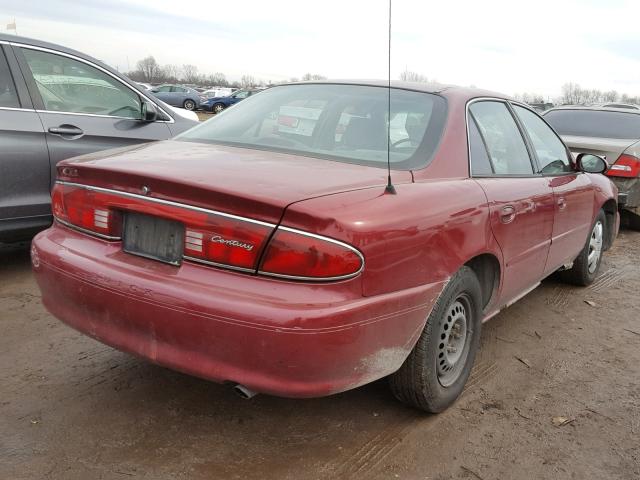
left=58, top=141, right=412, bottom=224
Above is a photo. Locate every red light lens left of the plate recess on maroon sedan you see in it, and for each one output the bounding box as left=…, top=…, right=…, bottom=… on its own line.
left=51, top=184, right=122, bottom=240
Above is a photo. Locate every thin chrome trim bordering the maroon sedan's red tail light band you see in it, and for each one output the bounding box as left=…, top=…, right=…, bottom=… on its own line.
left=56, top=180, right=364, bottom=282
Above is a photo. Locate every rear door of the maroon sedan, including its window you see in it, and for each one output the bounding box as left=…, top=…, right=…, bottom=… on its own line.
left=468, top=100, right=554, bottom=303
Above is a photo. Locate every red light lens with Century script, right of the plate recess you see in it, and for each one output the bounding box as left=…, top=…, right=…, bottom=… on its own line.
left=181, top=214, right=273, bottom=271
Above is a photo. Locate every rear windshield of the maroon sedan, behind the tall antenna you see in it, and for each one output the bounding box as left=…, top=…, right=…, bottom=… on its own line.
left=176, top=84, right=446, bottom=170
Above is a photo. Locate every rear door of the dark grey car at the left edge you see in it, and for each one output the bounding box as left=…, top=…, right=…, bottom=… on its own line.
left=0, top=43, right=50, bottom=225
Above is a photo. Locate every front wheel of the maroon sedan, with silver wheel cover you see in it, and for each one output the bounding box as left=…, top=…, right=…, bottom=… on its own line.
left=560, top=210, right=607, bottom=287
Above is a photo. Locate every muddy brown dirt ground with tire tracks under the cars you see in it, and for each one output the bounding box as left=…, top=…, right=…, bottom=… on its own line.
left=0, top=232, right=640, bottom=480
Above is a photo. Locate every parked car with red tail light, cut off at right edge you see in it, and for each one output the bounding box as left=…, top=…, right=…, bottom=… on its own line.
left=544, top=106, right=640, bottom=230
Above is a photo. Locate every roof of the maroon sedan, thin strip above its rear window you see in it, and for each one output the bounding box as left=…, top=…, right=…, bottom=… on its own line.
left=282, top=79, right=514, bottom=100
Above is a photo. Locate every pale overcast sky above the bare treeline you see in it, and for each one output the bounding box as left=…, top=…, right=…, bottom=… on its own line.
left=0, top=0, right=640, bottom=96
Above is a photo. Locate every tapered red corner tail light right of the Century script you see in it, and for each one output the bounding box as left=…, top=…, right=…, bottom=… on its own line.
left=259, top=227, right=364, bottom=281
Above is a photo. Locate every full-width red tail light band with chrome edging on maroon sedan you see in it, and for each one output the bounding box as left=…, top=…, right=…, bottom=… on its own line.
left=52, top=183, right=364, bottom=281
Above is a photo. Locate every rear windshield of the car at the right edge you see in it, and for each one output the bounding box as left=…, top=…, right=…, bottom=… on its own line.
left=544, top=110, right=640, bottom=140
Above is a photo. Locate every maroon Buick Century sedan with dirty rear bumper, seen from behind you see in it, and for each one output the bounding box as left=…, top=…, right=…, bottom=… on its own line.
left=32, top=82, right=619, bottom=412
